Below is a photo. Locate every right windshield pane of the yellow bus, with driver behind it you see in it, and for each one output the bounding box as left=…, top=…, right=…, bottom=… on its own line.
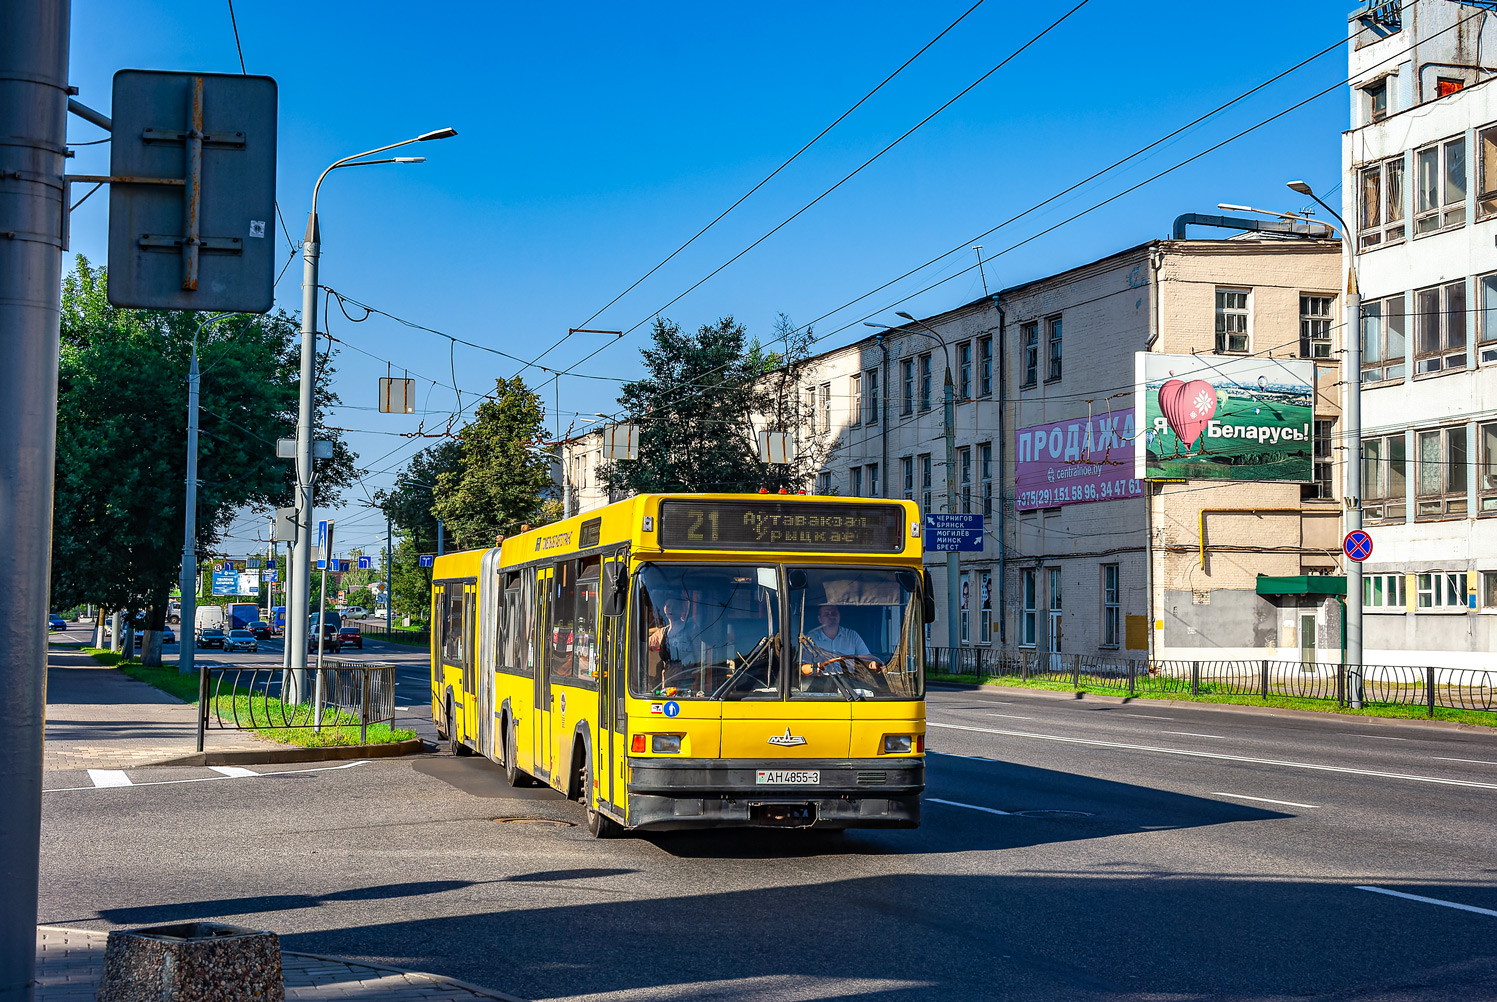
left=787, top=568, right=924, bottom=699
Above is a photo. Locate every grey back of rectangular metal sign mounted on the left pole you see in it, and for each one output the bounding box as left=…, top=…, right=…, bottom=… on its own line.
left=109, top=69, right=275, bottom=313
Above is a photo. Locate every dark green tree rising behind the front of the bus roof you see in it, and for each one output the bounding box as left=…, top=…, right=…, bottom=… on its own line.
left=599, top=315, right=825, bottom=493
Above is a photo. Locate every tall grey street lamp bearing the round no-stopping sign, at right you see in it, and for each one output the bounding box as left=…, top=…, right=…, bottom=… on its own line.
left=1286, top=181, right=1362, bottom=708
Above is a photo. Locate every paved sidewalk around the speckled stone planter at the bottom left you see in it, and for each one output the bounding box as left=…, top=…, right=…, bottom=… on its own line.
left=34, top=926, right=521, bottom=1002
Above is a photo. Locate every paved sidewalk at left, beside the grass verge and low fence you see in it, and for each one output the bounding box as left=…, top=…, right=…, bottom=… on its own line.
left=42, top=647, right=274, bottom=770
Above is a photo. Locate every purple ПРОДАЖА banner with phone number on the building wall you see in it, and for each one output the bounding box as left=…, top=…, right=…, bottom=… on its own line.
left=1013, top=410, right=1144, bottom=511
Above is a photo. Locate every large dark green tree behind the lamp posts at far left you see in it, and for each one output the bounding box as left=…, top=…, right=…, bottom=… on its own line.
left=52, top=256, right=359, bottom=664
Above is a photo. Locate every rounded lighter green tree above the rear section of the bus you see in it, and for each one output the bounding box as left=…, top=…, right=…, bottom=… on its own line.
left=433, top=376, right=555, bottom=550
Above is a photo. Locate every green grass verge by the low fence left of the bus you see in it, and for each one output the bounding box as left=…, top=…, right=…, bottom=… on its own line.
left=82, top=647, right=416, bottom=747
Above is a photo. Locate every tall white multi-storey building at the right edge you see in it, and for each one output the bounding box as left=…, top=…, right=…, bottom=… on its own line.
left=1341, top=0, right=1497, bottom=668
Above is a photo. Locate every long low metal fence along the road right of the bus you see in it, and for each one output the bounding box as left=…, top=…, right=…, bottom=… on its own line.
left=925, top=647, right=1497, bottom=716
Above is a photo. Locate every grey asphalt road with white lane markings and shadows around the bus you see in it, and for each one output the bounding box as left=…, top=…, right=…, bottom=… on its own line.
left=42, top=676, right=1497, bottom=1002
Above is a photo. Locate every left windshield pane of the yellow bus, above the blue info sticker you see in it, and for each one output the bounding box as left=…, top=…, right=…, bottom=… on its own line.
left=632, top=563, right=781, bottom=699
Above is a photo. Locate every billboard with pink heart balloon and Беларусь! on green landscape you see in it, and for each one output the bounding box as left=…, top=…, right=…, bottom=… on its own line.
left=1133, top=352, right=1314, bottom=484
